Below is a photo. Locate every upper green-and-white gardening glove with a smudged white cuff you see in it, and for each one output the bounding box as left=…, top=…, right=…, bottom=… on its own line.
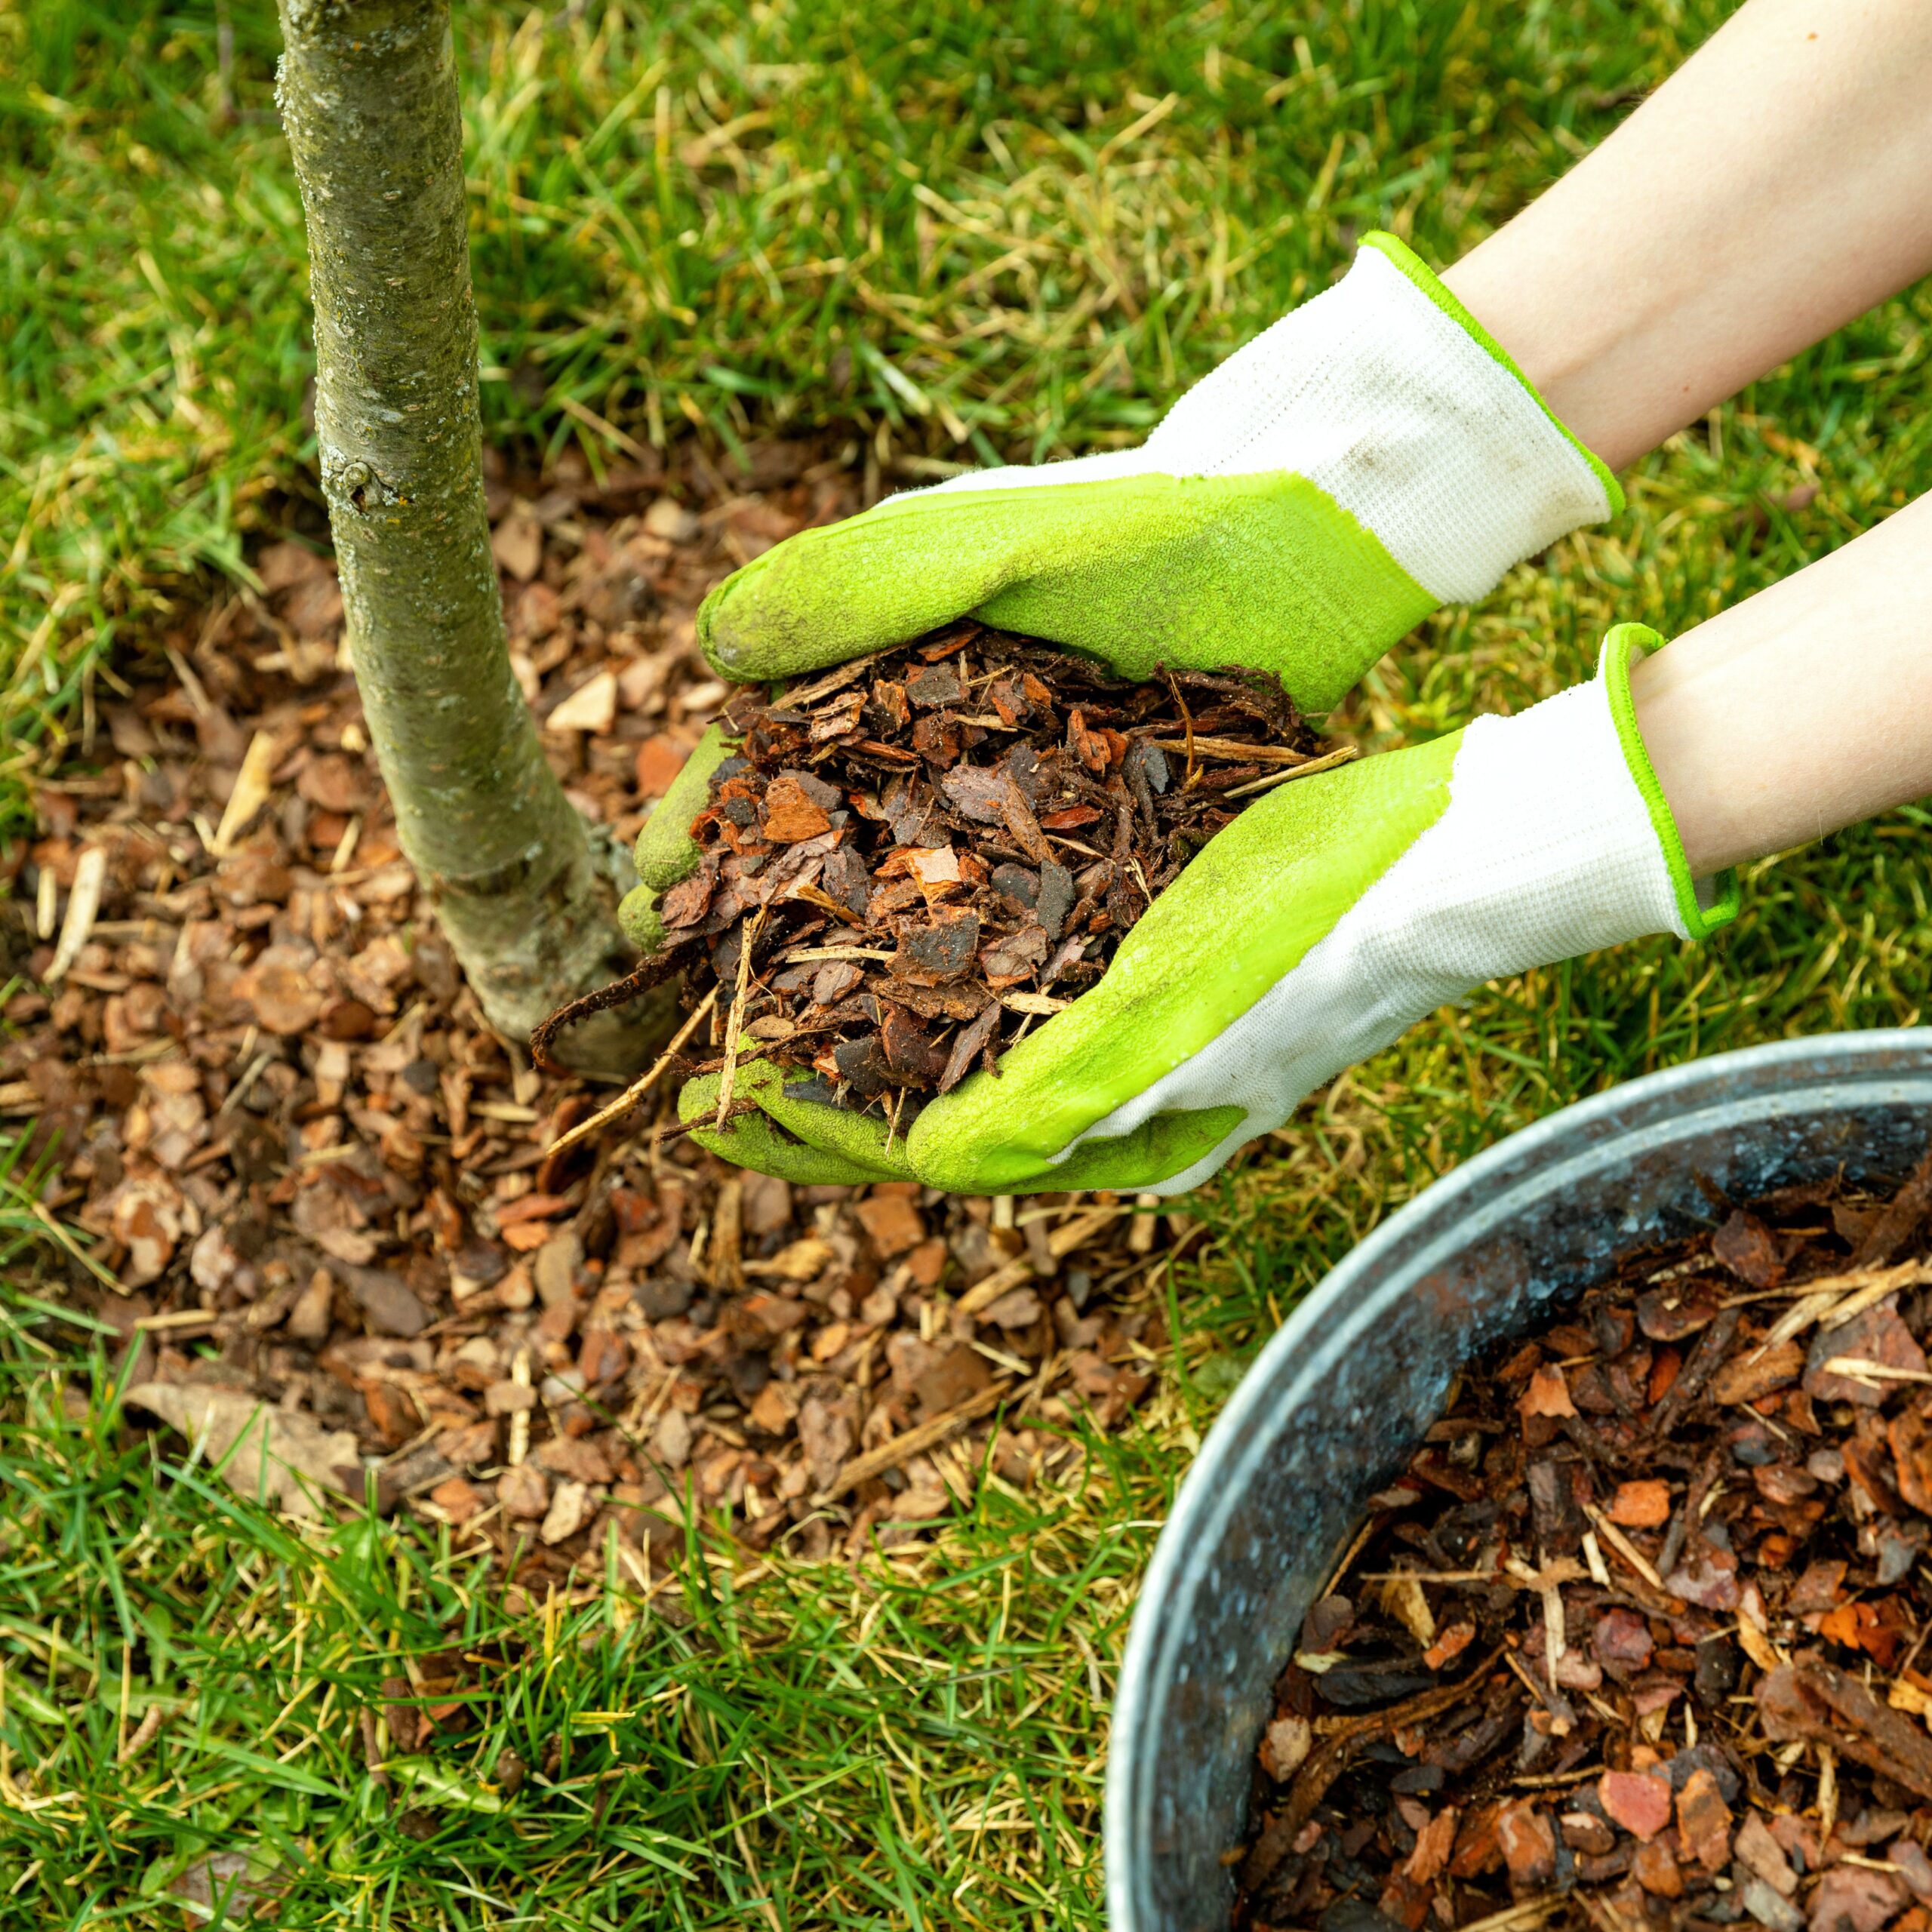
left=697, top=234, right=1623, bottom=713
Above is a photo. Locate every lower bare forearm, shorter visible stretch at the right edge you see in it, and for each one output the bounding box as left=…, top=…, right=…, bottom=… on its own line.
left=1631, top=497, right=1932, bottom=877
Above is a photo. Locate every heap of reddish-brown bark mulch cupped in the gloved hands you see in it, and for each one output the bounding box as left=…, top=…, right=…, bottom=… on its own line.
left=645, top=622, right=1329, bottom=1128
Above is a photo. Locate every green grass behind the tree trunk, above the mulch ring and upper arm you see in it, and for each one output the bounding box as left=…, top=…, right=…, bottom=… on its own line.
left=0, top=0, right=1725, bottom=836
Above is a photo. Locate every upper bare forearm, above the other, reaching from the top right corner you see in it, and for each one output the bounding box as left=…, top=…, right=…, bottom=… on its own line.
left=1443, top=0, right=1932, bottom=468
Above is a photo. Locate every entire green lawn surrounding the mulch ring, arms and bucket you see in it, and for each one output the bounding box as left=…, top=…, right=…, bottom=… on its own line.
left=11, top=0, right=1932, bottom=1932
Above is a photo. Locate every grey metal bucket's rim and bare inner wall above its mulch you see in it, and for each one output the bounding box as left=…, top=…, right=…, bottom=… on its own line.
left=1107, top=1028, right=1932, bottom=1932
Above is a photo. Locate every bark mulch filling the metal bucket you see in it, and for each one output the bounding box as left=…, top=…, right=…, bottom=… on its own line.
left=1231, top=1155, right=1932, bottom=1932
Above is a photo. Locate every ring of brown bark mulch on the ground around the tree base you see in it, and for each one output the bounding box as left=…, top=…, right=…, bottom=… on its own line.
left=11, top=445, right=1200, bottom=1596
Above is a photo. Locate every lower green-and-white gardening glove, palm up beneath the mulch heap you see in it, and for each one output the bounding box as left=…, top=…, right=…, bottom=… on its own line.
left=680, top=624, right=1737, bottom=1194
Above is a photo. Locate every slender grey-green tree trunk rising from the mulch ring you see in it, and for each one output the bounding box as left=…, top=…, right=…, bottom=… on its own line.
left=278, top=0, right=670, bottom=1072
